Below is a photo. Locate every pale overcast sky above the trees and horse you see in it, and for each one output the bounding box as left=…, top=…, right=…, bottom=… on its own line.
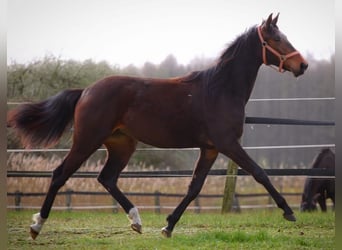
left=7, top=0, right=335, bottom=66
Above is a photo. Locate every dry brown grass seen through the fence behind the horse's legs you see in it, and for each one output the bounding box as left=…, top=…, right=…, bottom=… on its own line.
left=7, top=153, right=305, bottom=211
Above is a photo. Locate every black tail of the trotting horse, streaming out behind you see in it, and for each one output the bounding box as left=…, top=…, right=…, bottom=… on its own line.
left=7, top=89, right=83, bottom=148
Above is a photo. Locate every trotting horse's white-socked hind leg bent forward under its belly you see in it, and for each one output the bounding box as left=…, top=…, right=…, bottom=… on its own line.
left=98, top=131, right=142, bottom=233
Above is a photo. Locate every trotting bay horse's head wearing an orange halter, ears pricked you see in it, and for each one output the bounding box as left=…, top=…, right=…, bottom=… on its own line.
left=258, top=13, right=308, bottom=77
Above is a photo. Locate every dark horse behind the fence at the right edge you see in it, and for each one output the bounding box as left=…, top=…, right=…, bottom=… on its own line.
left=300, top=148, right=335, bottom=212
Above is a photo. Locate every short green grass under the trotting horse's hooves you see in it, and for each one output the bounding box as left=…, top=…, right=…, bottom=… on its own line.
left=7, top=209, right=335, bottom=250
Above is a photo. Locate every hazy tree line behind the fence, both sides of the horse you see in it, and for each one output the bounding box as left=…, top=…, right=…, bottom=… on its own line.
left=7, top=54, right=335, bottom=169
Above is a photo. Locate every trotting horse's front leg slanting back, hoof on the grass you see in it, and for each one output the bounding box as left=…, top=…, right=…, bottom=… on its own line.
left=162, top=149, right=218, bottom=237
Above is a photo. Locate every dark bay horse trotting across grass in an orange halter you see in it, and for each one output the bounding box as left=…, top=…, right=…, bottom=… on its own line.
left=7, top=14, right=308, bottom=238
